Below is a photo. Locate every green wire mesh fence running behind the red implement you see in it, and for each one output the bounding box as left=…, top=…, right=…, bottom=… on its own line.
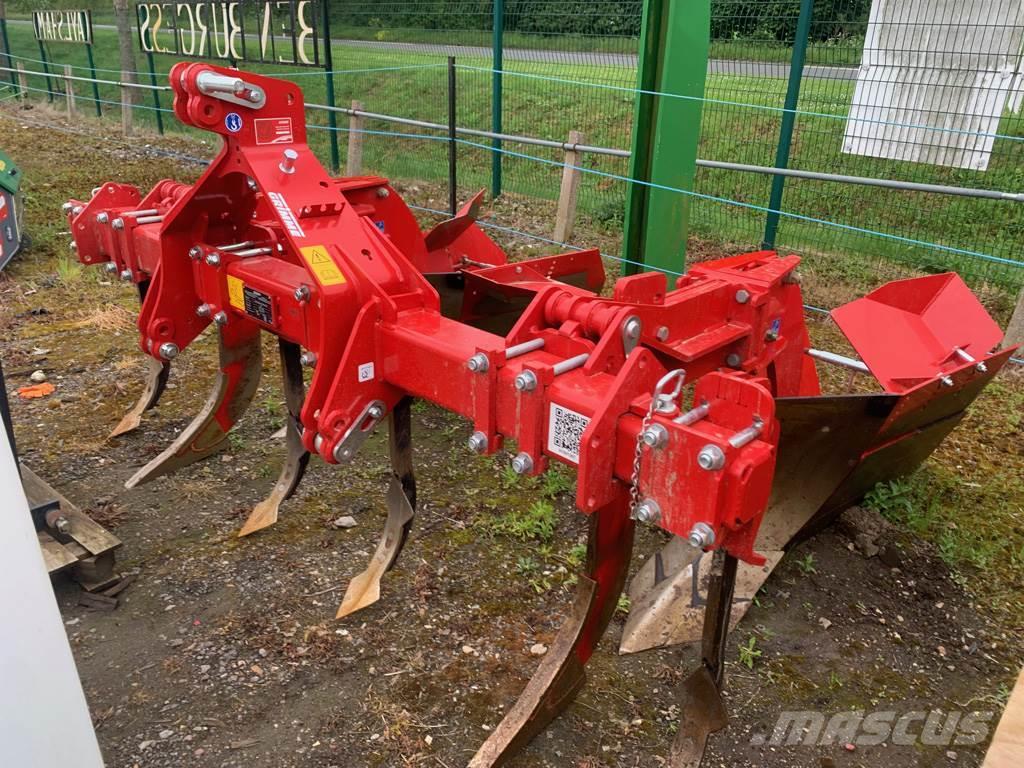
left=0, top=0, right=1024, bottom=309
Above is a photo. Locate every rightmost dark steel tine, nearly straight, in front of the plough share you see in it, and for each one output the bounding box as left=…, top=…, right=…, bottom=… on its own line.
left=669, top=550, right=738, bottom=768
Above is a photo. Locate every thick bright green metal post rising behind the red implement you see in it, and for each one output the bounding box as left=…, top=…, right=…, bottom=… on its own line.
left=623, top=0, right=711, bottom=274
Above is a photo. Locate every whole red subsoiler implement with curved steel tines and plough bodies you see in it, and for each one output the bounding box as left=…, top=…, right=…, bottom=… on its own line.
left=65, top=63, right=1012, bottom=766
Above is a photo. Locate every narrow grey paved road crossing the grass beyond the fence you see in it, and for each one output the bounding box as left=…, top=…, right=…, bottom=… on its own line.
left=7, top=18, right=857, bottom=80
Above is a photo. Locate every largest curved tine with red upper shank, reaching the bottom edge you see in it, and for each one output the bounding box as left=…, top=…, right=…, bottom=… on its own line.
left=469, top=494, right=635, bottom=768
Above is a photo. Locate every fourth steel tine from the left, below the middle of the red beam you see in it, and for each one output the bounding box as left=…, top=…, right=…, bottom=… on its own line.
left=336, top=397, right=416, bottom=618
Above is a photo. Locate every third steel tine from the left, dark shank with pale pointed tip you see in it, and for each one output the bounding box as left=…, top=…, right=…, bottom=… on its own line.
left=239, top=338, right=309, bottom=537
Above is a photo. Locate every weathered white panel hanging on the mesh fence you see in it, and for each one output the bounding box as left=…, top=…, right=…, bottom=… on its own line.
left=843, top=0, right=1024, bottom=171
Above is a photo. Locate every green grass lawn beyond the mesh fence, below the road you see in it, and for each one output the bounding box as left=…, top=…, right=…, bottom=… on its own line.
left=9, top=18, right=1024, bottom=292
